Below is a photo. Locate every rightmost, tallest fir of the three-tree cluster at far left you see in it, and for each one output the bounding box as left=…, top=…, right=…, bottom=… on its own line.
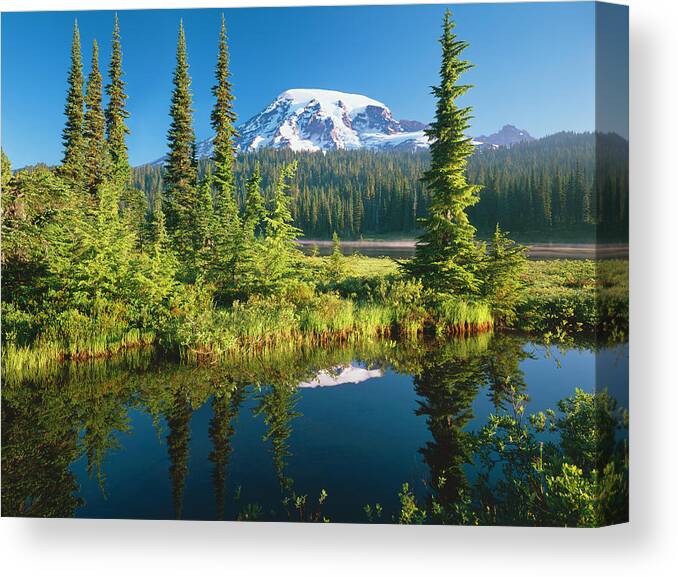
left=105, top=14, right=130, bottom=190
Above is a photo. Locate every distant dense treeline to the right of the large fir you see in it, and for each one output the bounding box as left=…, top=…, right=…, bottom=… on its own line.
left=469, top=132, right=629, bottom=240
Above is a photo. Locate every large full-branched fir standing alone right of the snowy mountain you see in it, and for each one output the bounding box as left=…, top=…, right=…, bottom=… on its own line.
left=404, top=10, right=483, bottom=295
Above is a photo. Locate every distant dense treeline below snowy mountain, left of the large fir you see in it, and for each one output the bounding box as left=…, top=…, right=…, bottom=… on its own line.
left=133, top=149, right=429, bottom=238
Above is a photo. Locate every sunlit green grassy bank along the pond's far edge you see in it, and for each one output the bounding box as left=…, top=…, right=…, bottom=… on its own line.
left=2, top=256, right=628, bottom=372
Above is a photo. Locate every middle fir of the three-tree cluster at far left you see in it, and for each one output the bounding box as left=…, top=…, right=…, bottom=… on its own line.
left=83, top=40, right=109, bottom=195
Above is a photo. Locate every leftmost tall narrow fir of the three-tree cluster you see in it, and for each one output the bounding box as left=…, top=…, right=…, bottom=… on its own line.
left=61, top=20, right=85, bottom=184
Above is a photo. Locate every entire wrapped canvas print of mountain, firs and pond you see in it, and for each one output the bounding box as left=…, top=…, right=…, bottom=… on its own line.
left=1, top=2, right=629, bottom=527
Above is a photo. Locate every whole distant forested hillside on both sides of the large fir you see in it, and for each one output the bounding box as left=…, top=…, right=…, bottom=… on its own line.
left=134, top=132, right=628, bottom=241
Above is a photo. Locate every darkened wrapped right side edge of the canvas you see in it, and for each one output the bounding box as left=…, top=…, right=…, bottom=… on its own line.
left=592, top=3, right=629, bottom=525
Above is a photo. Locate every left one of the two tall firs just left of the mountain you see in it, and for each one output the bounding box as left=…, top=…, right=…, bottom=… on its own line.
left=164, top=22, right=198, bottom=255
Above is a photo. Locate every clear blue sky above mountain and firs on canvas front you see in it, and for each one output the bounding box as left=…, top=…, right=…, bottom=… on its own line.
left=2, top=2, right=595, bottom=167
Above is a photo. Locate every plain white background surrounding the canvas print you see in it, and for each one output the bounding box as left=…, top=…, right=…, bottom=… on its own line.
left=0, top=0, right=678, bottom=577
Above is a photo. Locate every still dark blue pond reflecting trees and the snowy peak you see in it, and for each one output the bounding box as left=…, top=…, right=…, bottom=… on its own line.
left=2, top=335, right=628, bottom=522
